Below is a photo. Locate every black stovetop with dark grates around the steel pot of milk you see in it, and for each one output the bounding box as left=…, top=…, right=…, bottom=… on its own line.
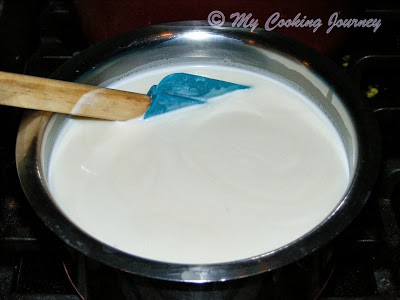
left=0, top=0, right=400, bottom=300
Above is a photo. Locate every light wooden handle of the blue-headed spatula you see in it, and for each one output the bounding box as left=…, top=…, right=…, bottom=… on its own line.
left=0, top=72, right=151, bottom=120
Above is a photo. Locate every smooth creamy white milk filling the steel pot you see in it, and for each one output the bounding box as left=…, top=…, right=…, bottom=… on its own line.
left=49, top=66, right=349, bottom=264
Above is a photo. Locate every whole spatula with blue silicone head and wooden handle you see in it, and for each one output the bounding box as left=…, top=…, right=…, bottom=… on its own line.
left=0, top=72, right=249, bottom=121
